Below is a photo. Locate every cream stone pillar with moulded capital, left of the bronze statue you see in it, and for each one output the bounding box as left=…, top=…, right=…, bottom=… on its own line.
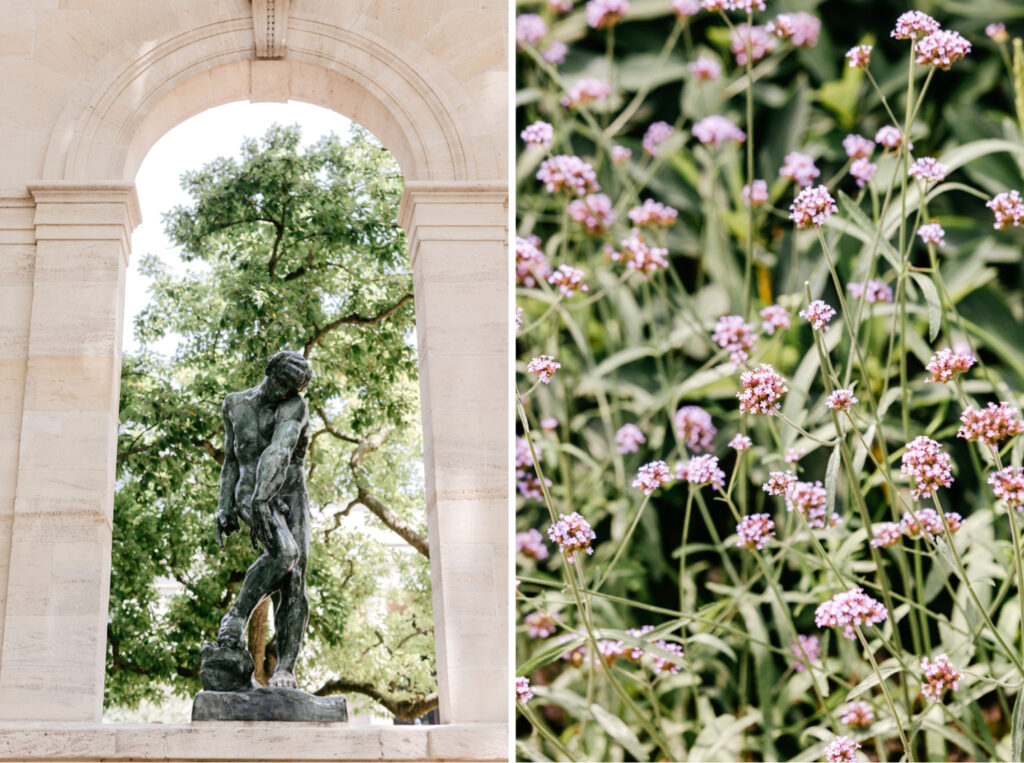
left=0, top=181, right=139, bottom=721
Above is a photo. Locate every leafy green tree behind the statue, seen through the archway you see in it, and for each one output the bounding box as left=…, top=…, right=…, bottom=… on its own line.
left=106, top=121, right=436, bottom=718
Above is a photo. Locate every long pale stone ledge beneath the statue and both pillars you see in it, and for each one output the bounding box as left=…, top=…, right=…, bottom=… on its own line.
left=0, top=721, right=509, bottom=763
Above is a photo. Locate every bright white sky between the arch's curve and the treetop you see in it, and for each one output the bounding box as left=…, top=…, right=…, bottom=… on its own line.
left=124, top=101, right=351, bottom=353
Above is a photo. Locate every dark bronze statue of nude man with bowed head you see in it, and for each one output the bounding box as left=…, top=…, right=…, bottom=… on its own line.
left=211, top=350, right=312, bottom=688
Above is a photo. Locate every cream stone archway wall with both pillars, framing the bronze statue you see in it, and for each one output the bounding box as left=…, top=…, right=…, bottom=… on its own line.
left=0, top=0, right=511, bottom=757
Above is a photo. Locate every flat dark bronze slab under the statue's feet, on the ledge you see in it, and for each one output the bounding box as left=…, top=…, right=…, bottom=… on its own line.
left=193, top=686, right=348, bottom=723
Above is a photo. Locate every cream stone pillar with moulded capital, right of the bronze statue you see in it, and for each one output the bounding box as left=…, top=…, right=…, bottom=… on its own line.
left=399, top=181, right=512, bottom=723
